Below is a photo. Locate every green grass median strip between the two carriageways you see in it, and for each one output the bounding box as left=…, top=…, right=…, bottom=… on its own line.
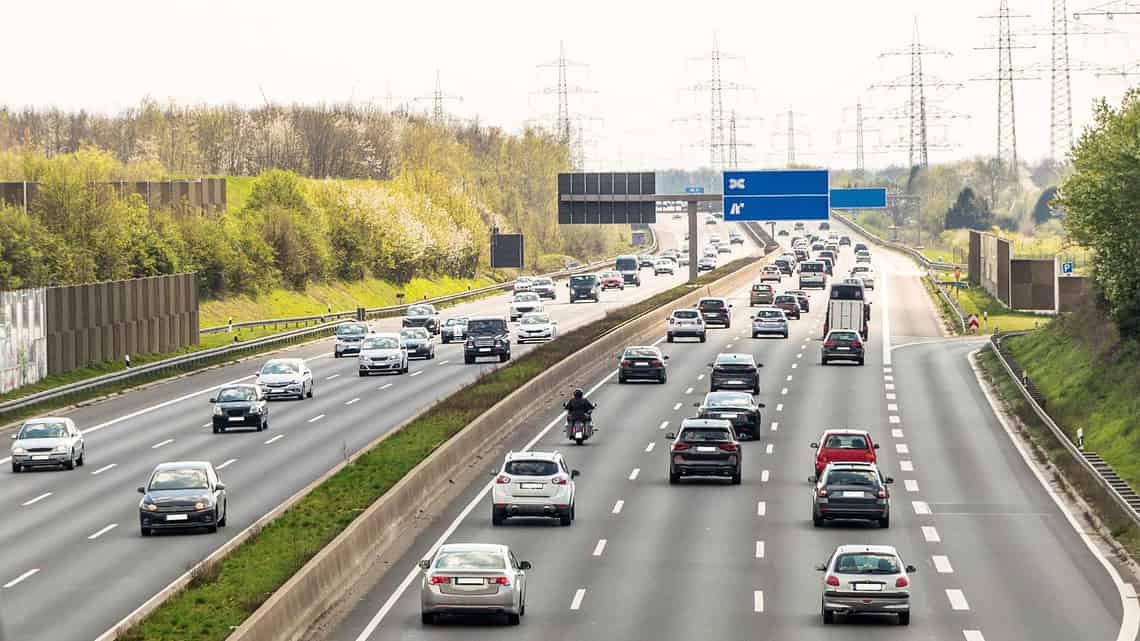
left=121, top=257, right=759, bottom=641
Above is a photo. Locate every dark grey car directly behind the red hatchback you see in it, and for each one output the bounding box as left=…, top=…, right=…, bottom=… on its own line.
left=812, top=463, right=895, bottom=528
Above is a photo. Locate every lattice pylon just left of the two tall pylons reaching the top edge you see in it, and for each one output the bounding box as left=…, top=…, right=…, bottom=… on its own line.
left=871, top=18, right=961, bottom=167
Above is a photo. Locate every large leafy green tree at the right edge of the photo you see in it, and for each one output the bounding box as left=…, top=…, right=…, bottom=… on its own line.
left=1057, top=89, right=1140, bottom=338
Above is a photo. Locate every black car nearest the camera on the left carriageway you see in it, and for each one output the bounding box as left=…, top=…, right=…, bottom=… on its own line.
left=139, top=461, right=229, bottom=536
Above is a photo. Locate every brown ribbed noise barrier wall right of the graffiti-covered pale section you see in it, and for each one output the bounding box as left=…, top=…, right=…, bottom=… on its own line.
left=46, top=274, right=198, bottom=374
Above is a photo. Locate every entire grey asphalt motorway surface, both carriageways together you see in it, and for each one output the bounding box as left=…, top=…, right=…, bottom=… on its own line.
left=0, top=214, right=1135, bottom=641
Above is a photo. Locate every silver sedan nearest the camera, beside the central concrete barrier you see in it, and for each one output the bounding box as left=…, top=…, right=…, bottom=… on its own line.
left=420, top=543, right=530, bottom=625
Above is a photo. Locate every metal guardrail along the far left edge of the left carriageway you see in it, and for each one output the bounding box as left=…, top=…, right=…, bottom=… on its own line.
left=0, top=229, right=658, bottom=423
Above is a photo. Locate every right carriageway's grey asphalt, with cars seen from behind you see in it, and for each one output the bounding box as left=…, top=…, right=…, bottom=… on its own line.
left=319, top=217, right=1137, bottom=641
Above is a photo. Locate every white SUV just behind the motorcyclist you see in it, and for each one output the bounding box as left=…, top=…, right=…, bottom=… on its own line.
left=491, top=452, right=578, bottom=526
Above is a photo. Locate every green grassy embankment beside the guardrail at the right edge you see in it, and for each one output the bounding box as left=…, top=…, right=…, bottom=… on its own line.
left=978, top=344, right=1140, bottom=559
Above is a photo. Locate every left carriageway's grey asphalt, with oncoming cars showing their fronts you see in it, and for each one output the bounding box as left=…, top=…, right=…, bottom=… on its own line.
left=0, top=213, right=759, bottom=641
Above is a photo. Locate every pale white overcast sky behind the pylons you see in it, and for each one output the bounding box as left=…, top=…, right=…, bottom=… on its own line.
left=8, top=0, right=1140, bottom=170
